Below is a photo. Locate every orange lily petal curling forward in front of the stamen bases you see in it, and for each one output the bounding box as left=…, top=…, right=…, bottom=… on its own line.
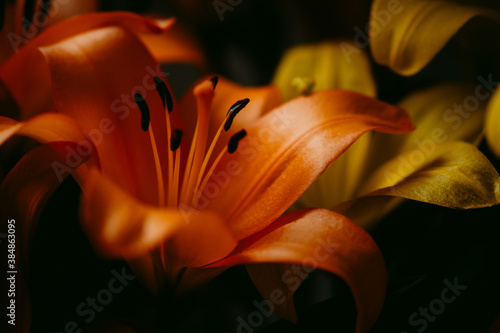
left=82, top=170, right=236, bottom=266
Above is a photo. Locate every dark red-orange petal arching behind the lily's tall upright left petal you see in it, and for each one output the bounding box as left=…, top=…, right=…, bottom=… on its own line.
left=0, top=12, right=174, bottom=119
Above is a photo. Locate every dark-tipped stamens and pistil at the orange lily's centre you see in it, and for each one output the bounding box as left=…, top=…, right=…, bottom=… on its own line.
left=134, top=76, right=250, bottom=207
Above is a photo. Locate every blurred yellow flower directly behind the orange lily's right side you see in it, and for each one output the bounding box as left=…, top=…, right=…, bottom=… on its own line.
left=274, top=41, right=500, bottom=227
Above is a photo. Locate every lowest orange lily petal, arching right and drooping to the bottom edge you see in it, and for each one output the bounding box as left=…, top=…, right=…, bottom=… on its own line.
left=208, top=209, right=387, bottom=332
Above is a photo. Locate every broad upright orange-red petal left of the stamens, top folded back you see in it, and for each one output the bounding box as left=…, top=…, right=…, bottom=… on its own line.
left=41, top=27, right=183, bottom=204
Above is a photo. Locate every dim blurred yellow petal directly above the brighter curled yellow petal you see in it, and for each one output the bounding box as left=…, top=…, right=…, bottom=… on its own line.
left=367, top=83, right=489, bottom=171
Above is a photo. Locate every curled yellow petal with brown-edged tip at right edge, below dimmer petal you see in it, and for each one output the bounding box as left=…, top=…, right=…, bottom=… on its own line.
left=336, top=142, right=500, bottom=227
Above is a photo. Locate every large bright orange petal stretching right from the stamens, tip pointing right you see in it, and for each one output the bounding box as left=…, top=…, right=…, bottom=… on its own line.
left=198, top=90, right=412, bottom=239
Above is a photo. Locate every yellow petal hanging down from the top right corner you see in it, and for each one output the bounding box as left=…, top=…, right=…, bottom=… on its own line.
left=370, top=0, right=500, bottom=75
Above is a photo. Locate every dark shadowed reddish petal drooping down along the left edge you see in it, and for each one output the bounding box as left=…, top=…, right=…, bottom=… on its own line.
left=0, top=142, right=90, bottom=332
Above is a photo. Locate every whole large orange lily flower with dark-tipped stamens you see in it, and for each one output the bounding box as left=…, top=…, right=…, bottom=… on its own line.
left=0, top=14, right=412, bottom=332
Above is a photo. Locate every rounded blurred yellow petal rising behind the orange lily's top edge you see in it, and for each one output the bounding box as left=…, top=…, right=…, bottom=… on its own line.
left=273, top=41, right=377, bottom=101
